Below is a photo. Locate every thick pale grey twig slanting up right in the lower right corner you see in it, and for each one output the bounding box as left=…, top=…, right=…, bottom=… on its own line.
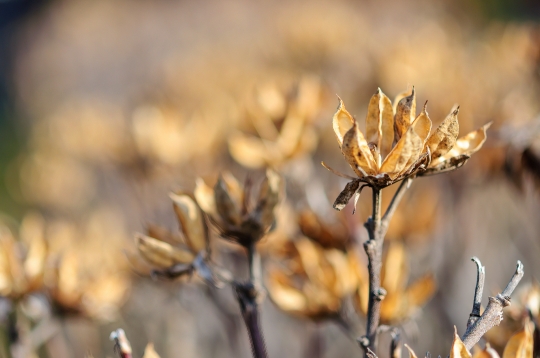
left=461, top=261, right=523, bottom=350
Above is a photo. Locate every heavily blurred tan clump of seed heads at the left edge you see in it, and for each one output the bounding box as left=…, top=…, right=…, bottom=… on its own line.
left=0, top=210, right=130, bottom=355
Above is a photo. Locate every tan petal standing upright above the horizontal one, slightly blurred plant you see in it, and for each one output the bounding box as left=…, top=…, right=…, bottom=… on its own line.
left=169, top=193, right=208, bottom=253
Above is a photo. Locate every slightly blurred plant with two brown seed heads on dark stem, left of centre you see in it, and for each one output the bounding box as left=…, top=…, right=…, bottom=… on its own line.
left=137, top=170, right=283, bottom=357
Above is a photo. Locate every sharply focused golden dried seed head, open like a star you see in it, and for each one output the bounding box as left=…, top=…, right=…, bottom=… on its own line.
left=323, top=88, right=489, bottom=210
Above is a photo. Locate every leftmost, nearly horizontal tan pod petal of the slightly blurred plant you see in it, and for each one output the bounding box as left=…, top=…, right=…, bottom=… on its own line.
left=135, top=235, right=195, bottom=268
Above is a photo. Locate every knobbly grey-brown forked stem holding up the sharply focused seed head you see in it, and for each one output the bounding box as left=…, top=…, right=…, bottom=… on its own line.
left=359, top=178, right=412, bottom=357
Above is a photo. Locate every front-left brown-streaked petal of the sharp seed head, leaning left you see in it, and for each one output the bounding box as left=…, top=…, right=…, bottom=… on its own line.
left=341, top=122, right=377, bottom=177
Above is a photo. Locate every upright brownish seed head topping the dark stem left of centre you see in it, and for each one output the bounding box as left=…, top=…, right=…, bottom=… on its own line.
left=195, top=169, right=282, bottom=247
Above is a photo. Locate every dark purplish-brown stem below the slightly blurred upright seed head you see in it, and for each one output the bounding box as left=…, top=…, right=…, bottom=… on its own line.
left=234, top=243, right=268, bottom=358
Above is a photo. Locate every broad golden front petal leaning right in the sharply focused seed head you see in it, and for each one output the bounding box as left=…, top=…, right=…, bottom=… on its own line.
left=381, top=127, right=422, bottom=179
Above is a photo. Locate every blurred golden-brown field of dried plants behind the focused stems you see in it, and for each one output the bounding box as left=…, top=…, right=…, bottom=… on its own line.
left=0, top=0, right=540, bottom=357
